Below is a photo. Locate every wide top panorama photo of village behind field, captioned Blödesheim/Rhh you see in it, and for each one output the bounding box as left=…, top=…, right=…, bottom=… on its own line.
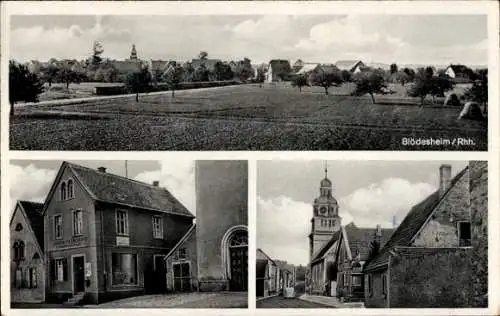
left=8, top=12, right=488, bottom=151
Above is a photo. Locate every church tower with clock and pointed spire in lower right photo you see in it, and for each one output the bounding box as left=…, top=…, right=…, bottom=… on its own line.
left=309, top=162, right=342, bottom=260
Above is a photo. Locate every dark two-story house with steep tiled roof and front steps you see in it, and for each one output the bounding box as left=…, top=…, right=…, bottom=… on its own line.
left=43, top=162, right=194, bottom=303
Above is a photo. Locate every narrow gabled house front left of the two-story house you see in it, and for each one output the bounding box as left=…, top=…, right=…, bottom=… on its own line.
left=9, top=201, right=45, bottom=303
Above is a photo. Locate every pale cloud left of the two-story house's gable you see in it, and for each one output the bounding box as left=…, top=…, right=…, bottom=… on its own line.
left=9, top=164, right=57, bottom=212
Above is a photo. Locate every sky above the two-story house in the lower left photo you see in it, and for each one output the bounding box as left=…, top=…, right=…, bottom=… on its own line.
left=9, top=160, right=196, bottom=215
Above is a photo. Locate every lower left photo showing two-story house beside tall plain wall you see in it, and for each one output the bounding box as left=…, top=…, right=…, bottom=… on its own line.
left=9, top=159, right=248, bottom=308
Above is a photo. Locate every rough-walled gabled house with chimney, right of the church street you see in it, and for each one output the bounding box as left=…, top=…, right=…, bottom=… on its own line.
left=364, top=162, right=487, bottom=308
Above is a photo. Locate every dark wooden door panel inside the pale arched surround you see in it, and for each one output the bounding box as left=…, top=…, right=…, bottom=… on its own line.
left=229, top=231, right=248, bottom=291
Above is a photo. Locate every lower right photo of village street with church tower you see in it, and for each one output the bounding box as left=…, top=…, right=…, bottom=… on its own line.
left=255, top=160, right=488, bottom=308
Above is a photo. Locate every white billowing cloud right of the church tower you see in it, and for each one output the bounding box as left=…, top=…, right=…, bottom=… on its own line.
left=340, top=178, right=436, bottom=227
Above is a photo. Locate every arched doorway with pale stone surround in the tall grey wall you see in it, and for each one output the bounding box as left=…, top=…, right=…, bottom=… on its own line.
left=222, top=225, right=248, bottom=291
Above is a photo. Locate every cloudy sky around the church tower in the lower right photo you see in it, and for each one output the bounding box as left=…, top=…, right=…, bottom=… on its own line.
left=257, top=160, right=467, bottom=265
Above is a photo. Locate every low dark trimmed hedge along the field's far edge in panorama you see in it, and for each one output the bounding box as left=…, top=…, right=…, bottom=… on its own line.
left=94, top=80, right=241, bottom=95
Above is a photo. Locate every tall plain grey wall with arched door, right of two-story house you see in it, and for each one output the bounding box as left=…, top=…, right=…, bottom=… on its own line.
left=195, top=160, right=248, bottom=291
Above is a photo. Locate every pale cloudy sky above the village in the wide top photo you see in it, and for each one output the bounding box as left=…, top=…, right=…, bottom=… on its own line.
left=10, top=15, right=488, bottom=65
